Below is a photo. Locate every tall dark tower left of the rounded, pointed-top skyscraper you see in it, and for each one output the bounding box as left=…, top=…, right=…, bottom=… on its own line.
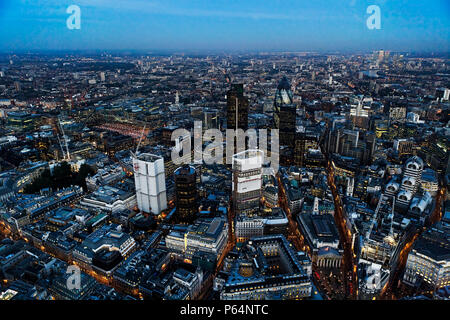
left=227, top=83, right=248, bottom=131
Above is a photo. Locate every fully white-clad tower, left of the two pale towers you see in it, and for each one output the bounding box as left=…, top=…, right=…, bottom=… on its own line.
left=133, top=153, right=167, bottom=215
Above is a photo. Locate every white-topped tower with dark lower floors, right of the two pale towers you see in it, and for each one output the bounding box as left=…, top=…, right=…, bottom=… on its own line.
left=232, top=149, right=264, bottom=216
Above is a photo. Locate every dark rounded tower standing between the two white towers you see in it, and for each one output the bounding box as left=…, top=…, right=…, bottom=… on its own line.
left=174, top=165, right=198, bottom=222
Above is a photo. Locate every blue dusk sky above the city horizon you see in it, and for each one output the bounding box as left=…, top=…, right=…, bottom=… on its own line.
left=0, top=0, right=450, bottom=52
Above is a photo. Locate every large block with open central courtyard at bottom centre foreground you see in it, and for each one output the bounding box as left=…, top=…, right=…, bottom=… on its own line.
left=220, top=235, right=312, bottom=300
